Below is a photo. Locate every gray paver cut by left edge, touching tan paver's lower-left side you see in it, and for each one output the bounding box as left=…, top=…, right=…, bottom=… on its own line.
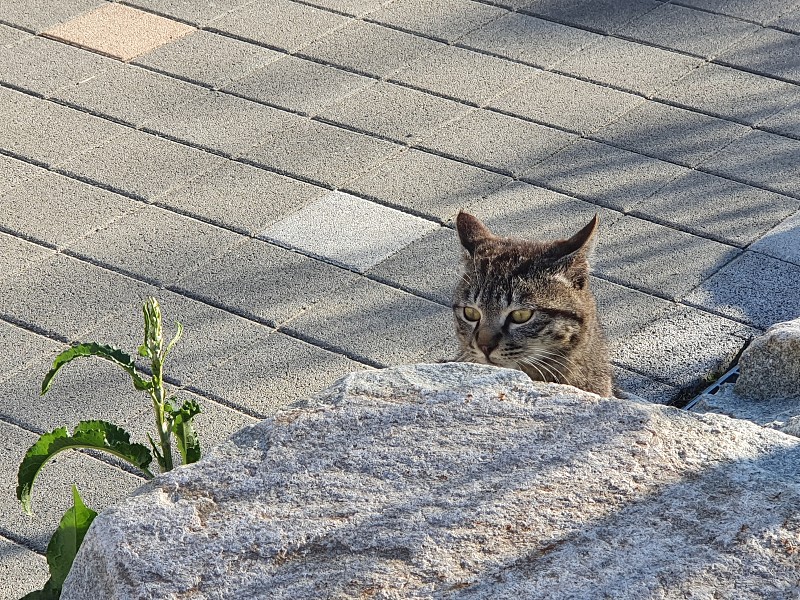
left=0, top=36, right=119, bottom=96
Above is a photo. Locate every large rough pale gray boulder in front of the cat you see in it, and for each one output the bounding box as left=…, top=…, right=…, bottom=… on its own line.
left=62, top=364, right=800, bottom=600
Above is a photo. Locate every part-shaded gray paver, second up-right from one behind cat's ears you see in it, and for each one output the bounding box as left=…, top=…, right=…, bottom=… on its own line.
left=597, top=102, right=750, bottom=167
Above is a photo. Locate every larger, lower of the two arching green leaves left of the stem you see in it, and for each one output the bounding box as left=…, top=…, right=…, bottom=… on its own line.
left=17, top=421, right=153, bottom=514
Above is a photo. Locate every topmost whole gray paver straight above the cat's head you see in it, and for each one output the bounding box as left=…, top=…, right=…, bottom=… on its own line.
left=459, top=13, right=601, bottom=69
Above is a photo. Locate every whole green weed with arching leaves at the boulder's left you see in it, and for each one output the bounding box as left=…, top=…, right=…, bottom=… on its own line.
left=17, top=298, right=200, bottom=600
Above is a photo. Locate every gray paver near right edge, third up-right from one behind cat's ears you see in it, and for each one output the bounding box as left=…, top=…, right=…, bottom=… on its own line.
left=656, top=63, right=800, bottom=125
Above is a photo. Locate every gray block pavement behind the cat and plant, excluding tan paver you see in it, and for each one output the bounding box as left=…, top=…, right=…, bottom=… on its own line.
left=0, top=0, right=800, bottom=599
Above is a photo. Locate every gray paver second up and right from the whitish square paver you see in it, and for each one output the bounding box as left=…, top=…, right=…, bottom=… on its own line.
left=419, top=110, right=579, bottom=177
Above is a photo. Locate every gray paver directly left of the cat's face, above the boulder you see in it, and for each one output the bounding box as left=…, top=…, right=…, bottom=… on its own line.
left=287, top=278, right=457, bottom=365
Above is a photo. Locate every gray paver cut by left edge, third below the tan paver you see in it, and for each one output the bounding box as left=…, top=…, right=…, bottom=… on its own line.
left=0, top=171, right=141, bottom=248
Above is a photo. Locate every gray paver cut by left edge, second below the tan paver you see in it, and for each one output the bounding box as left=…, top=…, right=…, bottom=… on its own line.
left=0, top=88, right=129, bottom=166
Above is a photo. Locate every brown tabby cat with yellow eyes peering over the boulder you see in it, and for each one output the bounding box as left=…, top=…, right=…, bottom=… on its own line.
left=452, top=211, right=613, bottom=396
